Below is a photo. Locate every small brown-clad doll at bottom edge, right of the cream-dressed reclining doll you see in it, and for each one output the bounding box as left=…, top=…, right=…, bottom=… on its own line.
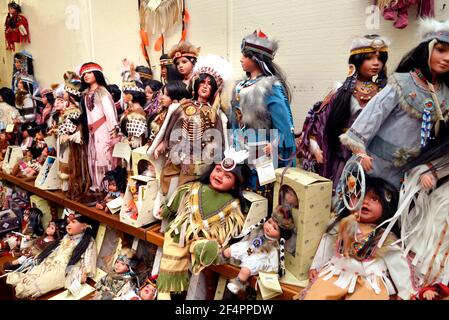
left=92, top=248, right=136, bottom=300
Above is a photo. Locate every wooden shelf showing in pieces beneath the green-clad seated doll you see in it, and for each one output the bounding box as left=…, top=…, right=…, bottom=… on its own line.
left=146, top=224, right=303, bottom=300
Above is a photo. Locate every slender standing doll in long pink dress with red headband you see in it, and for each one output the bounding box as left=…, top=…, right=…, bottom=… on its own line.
left=79, top=63, right=119, bottom=191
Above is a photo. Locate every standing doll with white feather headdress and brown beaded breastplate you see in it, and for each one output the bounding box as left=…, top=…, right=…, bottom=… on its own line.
left=148, top=55, right=231, bottom=195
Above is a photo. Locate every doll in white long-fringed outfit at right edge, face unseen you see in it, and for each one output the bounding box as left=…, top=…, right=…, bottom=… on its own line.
left=376, top=132, right=449, bottom=300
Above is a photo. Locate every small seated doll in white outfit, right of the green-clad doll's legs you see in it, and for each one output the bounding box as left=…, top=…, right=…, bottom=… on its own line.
left=223, top=206, right=295, bottom=294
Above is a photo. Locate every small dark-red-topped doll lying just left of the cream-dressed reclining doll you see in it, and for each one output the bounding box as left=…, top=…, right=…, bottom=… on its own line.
left=3, top=221, right=60, bottom=270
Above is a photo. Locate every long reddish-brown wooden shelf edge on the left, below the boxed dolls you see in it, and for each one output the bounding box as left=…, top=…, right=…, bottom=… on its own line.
left=0, top=170, right=150, bottom=240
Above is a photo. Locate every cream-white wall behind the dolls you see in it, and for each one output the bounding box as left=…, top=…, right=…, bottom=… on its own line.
left=0, top=0, right=449, bottom=129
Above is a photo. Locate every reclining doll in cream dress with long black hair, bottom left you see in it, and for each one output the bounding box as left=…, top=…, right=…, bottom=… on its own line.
left=6, top=209, right=97, bottom=299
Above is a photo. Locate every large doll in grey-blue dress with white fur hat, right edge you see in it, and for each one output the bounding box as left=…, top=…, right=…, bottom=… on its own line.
left=340, top=20, right=449, bottom=188
